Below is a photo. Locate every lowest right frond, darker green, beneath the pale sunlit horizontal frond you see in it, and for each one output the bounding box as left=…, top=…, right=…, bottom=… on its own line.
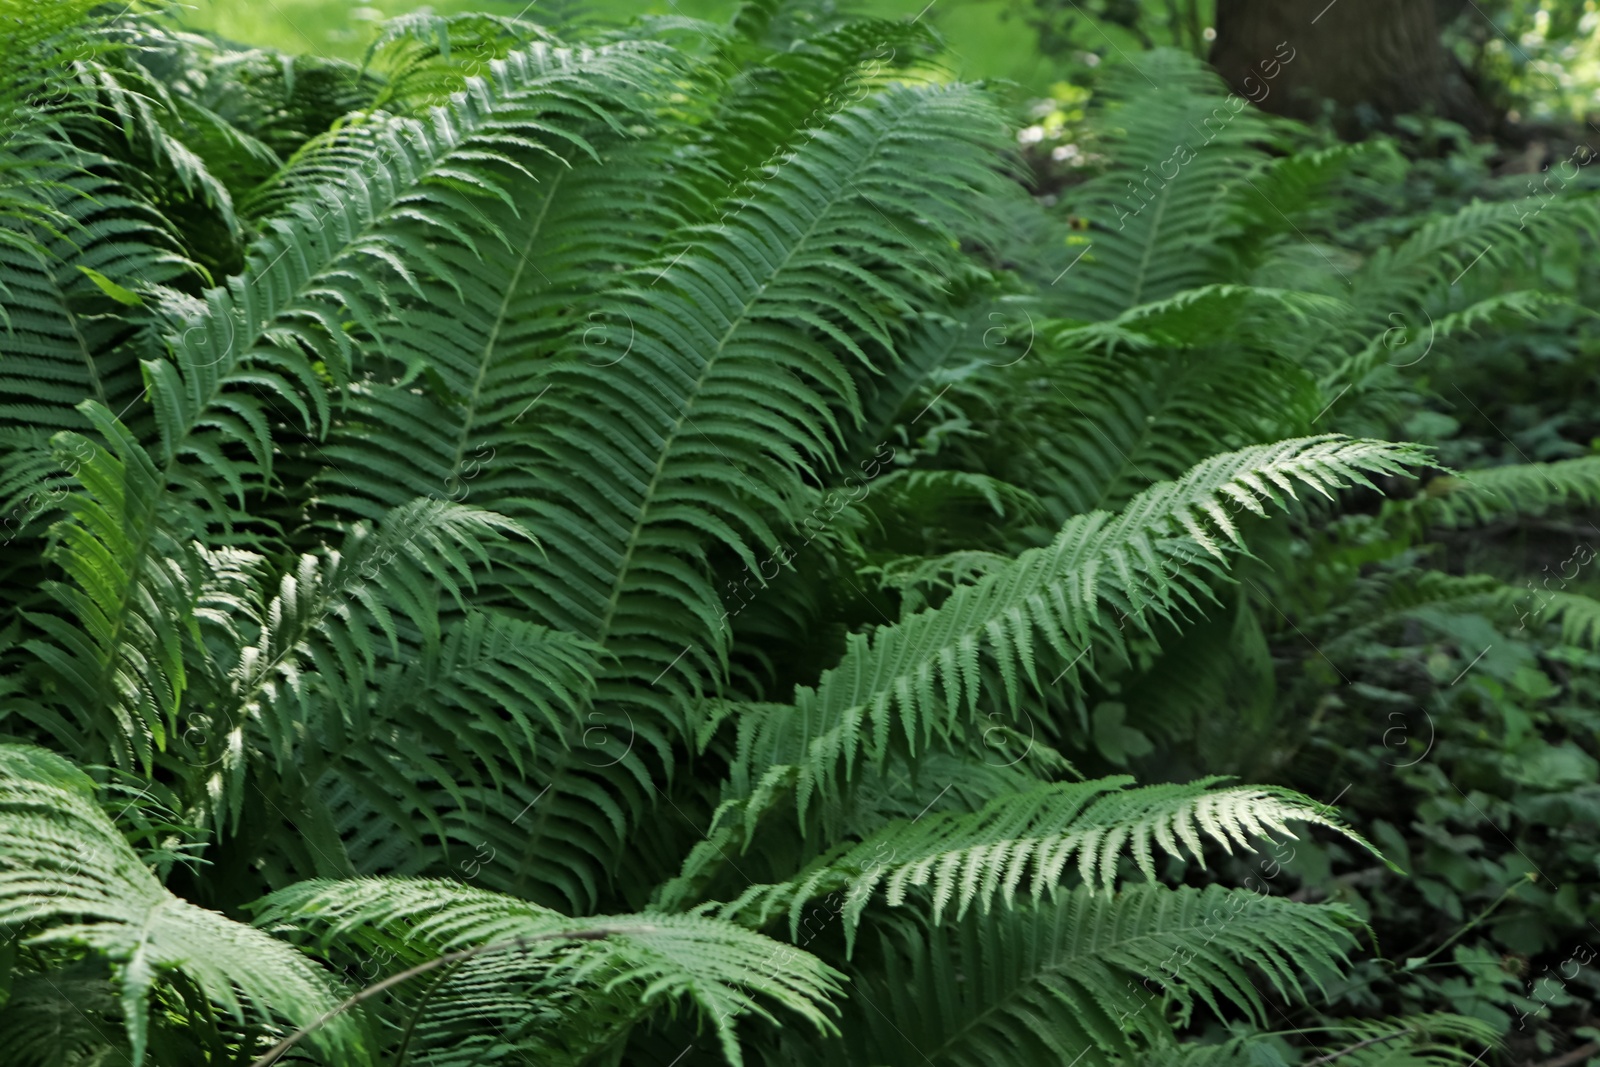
left=806, top=886, right=1355, bottom=1067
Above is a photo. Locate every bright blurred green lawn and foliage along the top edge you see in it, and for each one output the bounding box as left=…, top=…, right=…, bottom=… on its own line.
left=179, top=0, right=1600, bottom=131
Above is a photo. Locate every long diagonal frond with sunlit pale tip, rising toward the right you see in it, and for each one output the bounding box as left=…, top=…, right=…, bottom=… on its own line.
left=734, top=437, right=1422, bottom=813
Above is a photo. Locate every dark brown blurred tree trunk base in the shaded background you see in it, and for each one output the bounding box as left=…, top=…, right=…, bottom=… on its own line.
left=1211, top=0, right=1491, bottom=136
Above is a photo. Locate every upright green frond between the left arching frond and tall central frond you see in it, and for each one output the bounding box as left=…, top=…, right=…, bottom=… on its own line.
left=317, top=114, right=707, bottom=517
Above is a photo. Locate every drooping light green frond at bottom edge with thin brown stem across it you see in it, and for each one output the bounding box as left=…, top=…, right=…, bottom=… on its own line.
left=258, top=878, right=840, bottom=1064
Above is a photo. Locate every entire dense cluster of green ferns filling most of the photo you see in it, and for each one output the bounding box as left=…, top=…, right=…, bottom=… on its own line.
left=0, top=2, right=1600, bottom=1067
